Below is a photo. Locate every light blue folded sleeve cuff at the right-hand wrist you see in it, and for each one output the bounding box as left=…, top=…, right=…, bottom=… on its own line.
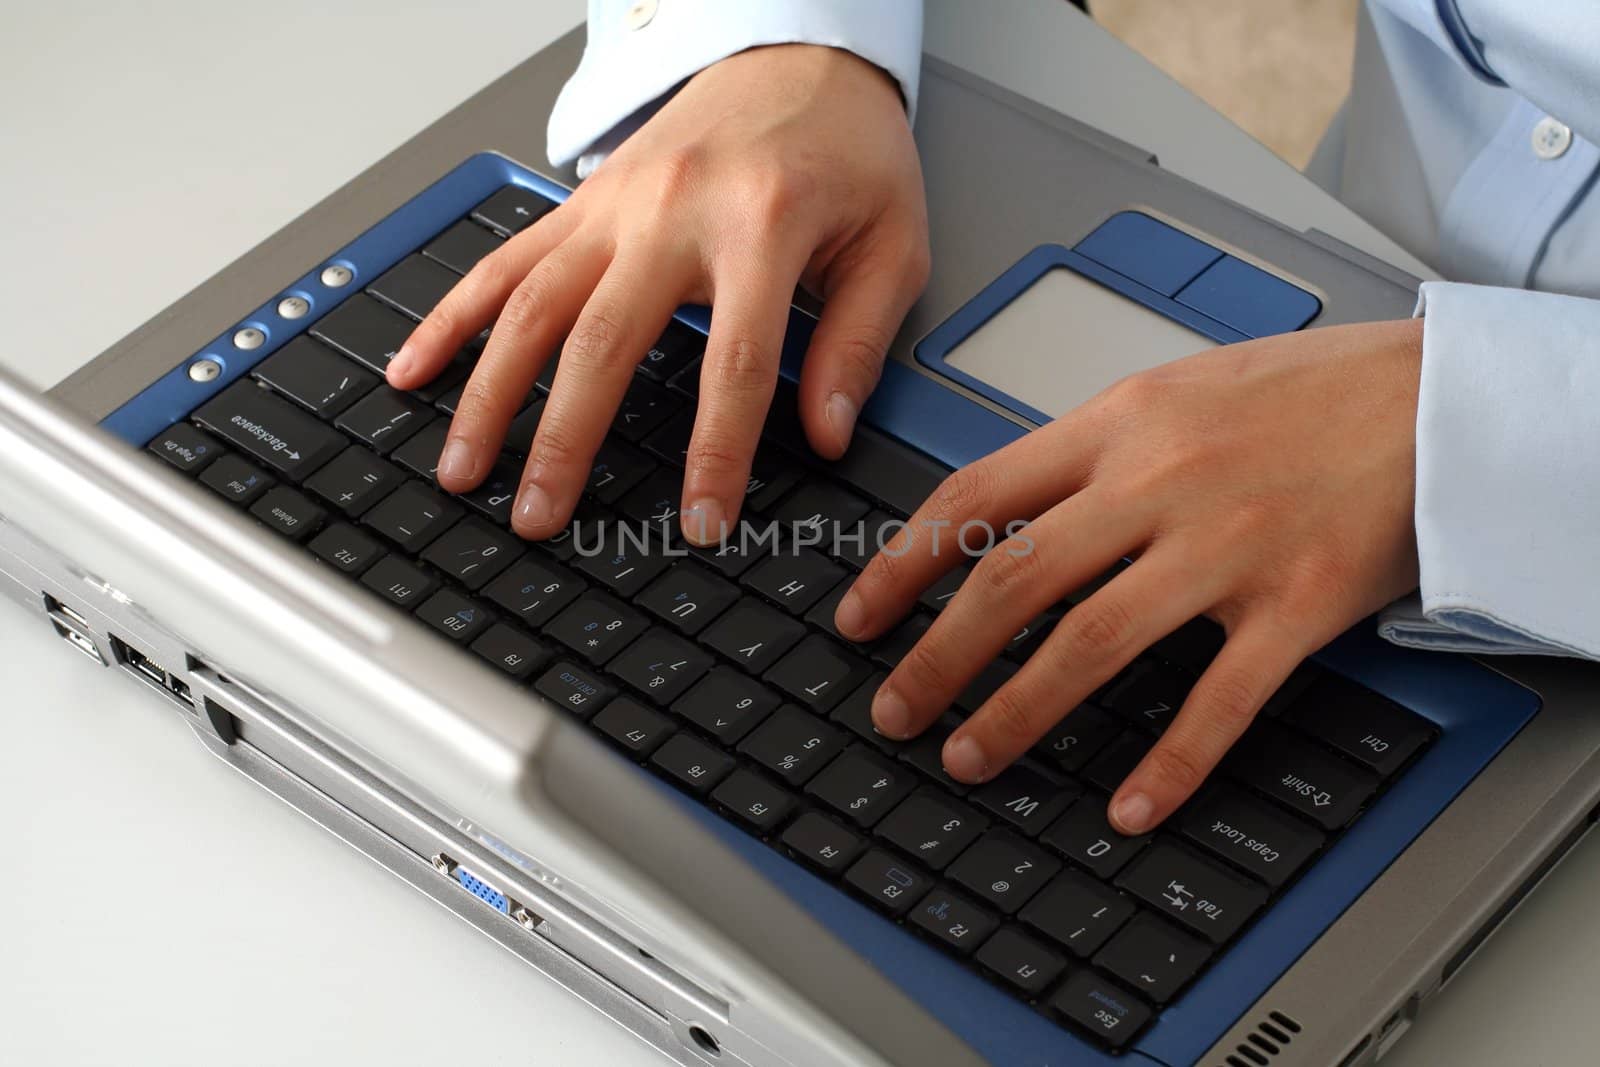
left=1379, top=282, right=1600, bottom=659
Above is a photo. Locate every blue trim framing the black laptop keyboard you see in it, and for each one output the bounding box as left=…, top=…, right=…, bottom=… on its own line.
left=104, top=154, right=1539, bottom=1065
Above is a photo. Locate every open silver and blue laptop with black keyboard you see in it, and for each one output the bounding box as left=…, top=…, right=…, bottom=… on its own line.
left=0, top=34, right=1600, bottom=1067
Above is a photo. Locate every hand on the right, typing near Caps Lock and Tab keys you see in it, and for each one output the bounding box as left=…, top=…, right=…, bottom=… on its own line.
left=837, top=320, right=1422, bottom=833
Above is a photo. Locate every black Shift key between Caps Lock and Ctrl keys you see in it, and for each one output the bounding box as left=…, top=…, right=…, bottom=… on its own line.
left=1222, top=723, right=1378, bottom=830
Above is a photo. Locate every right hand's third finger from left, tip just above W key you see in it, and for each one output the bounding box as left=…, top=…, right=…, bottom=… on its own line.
left=944, top=544, right=1221, bottom=782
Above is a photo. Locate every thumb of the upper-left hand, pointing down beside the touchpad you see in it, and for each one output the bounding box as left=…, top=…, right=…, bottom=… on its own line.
left=800, top=245, right=928, bottom=459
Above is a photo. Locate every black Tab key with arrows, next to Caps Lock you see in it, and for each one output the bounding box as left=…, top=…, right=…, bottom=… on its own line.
left=1117, top=840, right=1267, bottom=944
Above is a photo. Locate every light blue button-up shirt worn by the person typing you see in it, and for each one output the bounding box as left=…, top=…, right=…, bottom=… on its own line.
left=549, top=0, right=1600, bottom=659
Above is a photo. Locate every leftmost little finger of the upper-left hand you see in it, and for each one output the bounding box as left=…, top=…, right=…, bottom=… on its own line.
left=387, top=208, right=578, bottom=389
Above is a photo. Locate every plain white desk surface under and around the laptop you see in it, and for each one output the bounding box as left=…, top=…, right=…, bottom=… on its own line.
left=0, top=0, right=1600, bottom=1067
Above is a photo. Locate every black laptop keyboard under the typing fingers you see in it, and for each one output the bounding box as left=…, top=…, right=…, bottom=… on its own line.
left=140, top=186, right=1434, bottom=1049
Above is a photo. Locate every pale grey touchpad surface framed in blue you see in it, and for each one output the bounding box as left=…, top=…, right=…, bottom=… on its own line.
left=944, top=267, right=1216, bottom=419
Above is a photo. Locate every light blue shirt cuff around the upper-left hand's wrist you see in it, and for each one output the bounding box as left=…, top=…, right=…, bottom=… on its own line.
left=547, top=0, right=922, bottom=174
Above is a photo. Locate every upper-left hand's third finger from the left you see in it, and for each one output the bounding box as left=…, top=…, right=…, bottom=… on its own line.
left=512, top=245, right=690, bottom=539
